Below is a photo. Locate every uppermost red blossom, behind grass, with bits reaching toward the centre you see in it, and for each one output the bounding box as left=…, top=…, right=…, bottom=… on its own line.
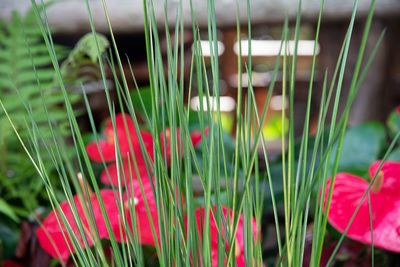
left=86, top=113, right=208, bottom=186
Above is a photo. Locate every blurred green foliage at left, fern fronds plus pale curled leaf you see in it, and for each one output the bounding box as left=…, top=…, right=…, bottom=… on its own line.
left=0, top=3, right=108, bottom=258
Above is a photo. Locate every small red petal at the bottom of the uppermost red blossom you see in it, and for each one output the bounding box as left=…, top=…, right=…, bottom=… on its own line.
left=100, top=160, right=152, bottom=186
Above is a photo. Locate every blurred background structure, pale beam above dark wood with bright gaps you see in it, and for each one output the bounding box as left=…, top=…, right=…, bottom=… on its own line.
left=0, top=0, right=400, bottom=150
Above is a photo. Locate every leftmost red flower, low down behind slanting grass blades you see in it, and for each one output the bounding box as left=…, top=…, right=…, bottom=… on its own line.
left=36, top=190, right=120, bottom=262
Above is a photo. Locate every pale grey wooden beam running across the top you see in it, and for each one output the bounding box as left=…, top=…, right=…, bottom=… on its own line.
left=0, top=0, right=400, bottom=33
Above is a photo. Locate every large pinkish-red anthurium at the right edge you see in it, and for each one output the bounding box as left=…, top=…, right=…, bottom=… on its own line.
left=325, top=161, right=400, bottom=252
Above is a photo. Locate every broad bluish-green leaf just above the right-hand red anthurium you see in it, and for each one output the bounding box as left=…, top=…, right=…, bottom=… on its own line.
left=331, top=122, right=386, bottom=175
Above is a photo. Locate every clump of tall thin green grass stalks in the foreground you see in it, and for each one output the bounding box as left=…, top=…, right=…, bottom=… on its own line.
left=0, top=0, right=390, bottom=266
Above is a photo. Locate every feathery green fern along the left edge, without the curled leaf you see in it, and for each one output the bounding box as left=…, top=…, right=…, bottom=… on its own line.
left=0, top=4, right=80, bottom=220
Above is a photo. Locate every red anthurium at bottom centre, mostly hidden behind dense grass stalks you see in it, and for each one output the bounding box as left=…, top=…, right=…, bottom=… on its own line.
left=195, top=207, right=261, bottom=267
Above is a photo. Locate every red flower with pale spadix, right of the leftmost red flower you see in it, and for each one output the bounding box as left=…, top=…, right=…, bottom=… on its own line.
left=119, top=178, right=160, bottom=246
